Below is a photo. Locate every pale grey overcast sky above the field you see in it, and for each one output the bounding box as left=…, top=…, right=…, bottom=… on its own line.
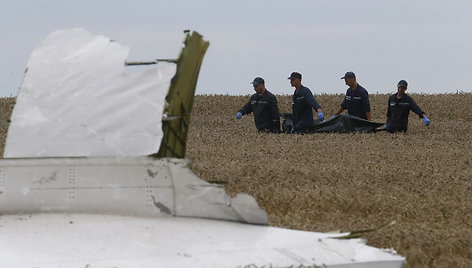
left=0, top=0, right=472, bottom=96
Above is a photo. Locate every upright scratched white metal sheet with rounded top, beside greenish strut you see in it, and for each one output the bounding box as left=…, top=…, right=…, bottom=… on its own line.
left=4, top=29, right=176, bottom=158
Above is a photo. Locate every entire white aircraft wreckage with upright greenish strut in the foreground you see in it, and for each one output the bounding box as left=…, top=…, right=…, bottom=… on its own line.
left=0, top=29, right=405, bottom=268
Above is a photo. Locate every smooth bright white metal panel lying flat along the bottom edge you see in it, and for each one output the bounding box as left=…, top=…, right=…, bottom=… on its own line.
left=0, top=214, right=405, bottom=268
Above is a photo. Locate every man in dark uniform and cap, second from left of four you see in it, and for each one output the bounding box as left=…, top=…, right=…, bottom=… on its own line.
left=288, top=72, right=324, bottom=133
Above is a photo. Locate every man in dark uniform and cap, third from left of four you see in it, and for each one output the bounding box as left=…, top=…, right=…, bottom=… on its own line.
left=333, top=72, right=370, bottom=121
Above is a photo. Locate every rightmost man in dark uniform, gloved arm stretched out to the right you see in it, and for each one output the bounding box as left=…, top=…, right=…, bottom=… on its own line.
left=385, top=80, right=431, bottom=133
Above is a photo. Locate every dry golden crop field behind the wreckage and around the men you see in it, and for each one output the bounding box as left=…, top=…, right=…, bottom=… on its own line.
left=0, top=93, right=472, bottom=267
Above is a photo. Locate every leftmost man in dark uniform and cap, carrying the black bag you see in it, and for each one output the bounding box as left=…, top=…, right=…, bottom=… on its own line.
left=236, top=77, right=280, bottom=133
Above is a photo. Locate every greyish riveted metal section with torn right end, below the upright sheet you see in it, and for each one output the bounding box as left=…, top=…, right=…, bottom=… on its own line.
left=0, top=157, right=267, bottom=224
